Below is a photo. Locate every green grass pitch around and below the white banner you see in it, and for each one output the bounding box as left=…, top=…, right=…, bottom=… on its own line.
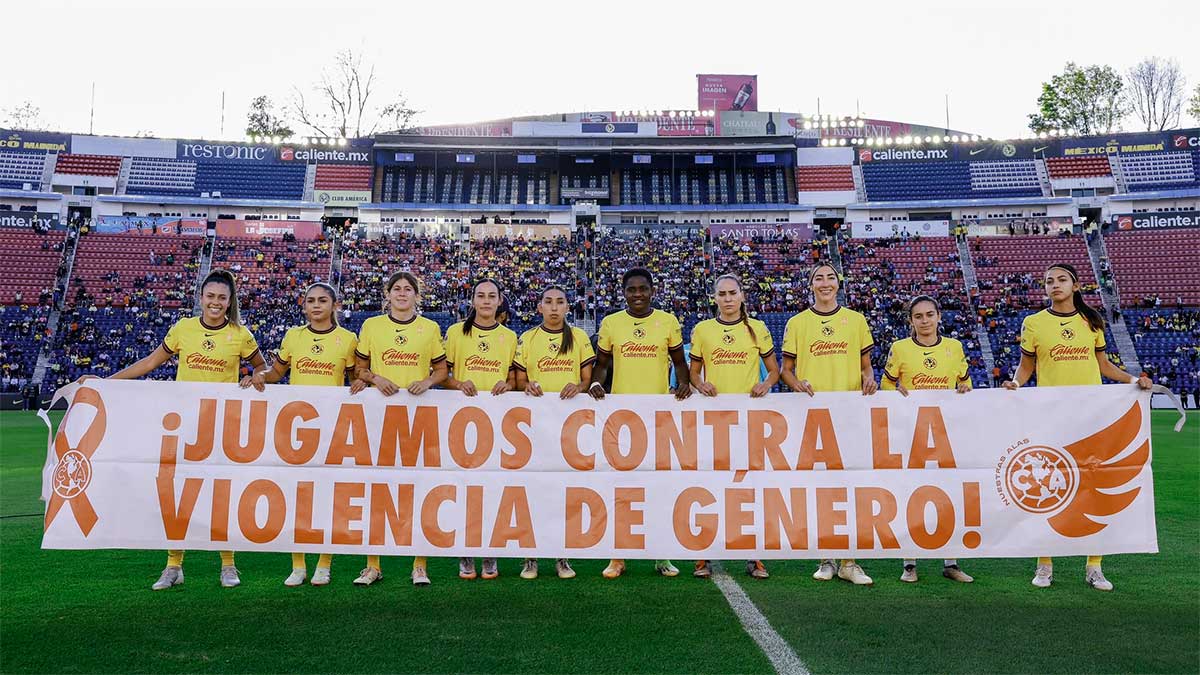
left=0, top=412, right=1200, bottom=673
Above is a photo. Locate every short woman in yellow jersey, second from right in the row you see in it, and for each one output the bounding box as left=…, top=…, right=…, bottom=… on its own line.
left=882, top=295, right=974, bottom=584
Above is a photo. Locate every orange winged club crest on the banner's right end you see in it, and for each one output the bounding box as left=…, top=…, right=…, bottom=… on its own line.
left=996, top=402, right=1150, bottom=538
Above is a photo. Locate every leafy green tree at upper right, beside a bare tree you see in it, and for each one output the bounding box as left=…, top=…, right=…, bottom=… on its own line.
left=1030, top=61, right=1129, bottom=135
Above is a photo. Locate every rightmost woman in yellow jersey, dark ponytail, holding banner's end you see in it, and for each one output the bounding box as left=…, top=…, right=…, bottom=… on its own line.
left=1004, top=263, right=1154, bottom=591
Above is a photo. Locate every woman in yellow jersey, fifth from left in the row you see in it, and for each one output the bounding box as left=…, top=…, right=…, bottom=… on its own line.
left=512, top=286, right=596, bottom=579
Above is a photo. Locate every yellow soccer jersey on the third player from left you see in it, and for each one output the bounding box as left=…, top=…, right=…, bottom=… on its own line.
left=355, top=315, right=446, bottom=389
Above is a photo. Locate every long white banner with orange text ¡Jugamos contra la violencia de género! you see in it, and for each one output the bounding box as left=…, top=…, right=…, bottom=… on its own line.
left=42, top=381, right=1158, bottom=560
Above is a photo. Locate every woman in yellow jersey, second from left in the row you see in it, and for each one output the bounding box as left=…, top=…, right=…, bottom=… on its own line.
left=241, top=282, right=357, bottom=586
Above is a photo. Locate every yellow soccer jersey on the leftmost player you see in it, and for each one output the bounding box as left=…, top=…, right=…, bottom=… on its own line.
left=162, top=316, right=258, bottom=382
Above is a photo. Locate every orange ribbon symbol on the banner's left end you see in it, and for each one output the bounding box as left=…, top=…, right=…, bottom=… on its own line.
left=46, top=389, right=108, bottom=537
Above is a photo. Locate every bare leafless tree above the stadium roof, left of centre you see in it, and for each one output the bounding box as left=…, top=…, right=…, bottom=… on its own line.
left=288, top=49, right=419, bottom=138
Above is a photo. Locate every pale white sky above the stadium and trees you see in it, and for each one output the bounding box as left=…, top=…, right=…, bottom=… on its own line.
left=0, top=0, right=1200, bottom=139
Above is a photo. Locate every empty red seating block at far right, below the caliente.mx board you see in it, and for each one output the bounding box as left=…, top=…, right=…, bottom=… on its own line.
left=1104, top=228, right=1200, bottom=307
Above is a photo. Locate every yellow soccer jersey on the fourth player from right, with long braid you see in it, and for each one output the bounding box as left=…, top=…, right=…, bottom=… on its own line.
left=691, top=318, right=775, bottom=394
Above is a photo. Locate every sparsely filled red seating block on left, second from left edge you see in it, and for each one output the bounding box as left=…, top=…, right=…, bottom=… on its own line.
left=67, top=233, right=204, bottom=310
